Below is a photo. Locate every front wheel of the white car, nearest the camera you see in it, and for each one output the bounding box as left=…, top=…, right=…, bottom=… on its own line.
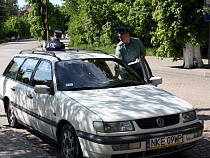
left=60, top=124, right=83, bottom=158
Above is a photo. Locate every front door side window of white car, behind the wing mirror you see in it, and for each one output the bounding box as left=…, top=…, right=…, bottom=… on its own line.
left=32, top=61, right=52, bottom=87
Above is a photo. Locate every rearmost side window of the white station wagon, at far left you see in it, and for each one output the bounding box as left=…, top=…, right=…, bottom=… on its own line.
left=3, top=58, right=25, bottom=79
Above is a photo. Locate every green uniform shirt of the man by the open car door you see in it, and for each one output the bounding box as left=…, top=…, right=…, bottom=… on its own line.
left=116, top=37, right=146, bottom=64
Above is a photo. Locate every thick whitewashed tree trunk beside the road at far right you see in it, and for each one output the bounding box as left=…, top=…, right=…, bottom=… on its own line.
left=183, top=42, right=203, bottom=69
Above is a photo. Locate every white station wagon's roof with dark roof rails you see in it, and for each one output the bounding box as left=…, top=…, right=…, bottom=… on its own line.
left=16, top=49, right=115, bottom=60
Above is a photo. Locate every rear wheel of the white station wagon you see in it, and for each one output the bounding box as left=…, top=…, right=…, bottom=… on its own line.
left=7, top=101, right=20, bottom=127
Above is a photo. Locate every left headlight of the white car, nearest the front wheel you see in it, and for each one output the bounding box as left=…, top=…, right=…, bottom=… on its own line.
left=93, top=121, right=134, bottom=133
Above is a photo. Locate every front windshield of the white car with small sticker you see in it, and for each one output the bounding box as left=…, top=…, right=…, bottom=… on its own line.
left=55, top=59, right=145, bottom=91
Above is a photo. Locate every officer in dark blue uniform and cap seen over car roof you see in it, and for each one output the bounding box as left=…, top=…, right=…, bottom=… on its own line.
left=45, top=30, right=65, bottom=51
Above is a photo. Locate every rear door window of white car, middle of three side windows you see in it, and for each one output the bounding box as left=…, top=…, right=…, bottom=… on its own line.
left=17, top=59, right=39, bottom=84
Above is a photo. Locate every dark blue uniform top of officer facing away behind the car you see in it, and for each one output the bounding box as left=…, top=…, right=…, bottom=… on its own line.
left=45, top=38, right=65, bottom=51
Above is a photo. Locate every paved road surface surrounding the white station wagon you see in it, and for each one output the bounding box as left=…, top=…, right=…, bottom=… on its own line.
left=0, top=39, right=210, bottom=158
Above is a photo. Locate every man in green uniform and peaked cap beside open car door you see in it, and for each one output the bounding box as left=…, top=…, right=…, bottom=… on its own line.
left=114, top=27, right=146, bottom=79
